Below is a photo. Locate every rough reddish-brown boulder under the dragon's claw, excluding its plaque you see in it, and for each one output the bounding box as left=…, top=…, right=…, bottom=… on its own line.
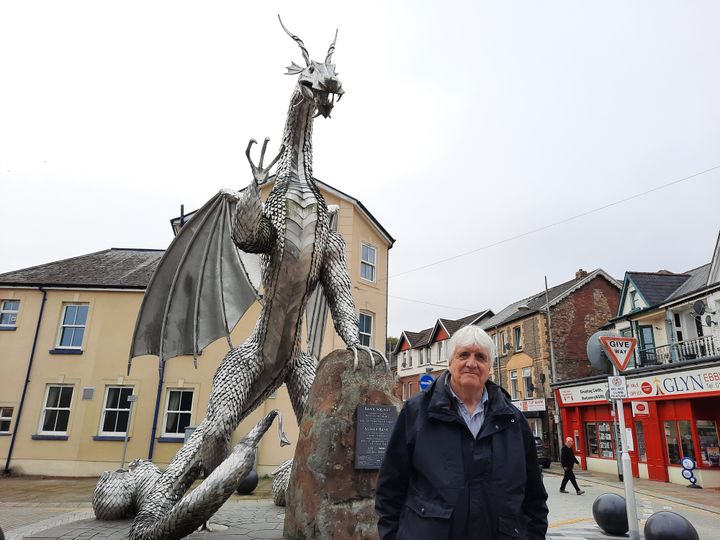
left=284, top=350, right=401, bottom=540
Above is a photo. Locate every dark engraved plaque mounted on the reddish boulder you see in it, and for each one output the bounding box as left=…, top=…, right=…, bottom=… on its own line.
left=355, top=405, right=397, bottom=469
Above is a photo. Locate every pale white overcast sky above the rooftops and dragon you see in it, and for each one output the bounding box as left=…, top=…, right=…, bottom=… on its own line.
left=0, top=0, right=720, bottom=335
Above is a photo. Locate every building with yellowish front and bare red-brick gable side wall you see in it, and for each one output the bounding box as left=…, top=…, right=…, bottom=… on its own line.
left=481, top=269, right=621, bottom=456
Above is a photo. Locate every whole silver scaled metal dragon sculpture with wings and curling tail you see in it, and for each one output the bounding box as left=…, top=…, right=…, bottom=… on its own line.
left=94, top=16, right=387, bottom=540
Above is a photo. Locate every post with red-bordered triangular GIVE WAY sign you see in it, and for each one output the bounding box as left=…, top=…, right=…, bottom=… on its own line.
left=599, top=336, right=640, bottom=540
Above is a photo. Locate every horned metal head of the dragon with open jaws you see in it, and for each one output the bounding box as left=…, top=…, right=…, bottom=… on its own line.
left=278, top=15, right=345, bottom=118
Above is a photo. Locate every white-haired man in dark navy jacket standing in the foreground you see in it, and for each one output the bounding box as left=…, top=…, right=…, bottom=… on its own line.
left=375, top=326, right=548, bottom=540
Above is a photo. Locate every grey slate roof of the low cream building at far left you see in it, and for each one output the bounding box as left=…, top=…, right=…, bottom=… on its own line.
left=0, top=248, right=165, bottom=289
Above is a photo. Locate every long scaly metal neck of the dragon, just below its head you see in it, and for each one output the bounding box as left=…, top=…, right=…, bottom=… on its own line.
left=277, top=87, right=315, bottom=188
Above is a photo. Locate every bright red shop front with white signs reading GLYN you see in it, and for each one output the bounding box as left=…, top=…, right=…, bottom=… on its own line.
left=554, top=358, right=720, bottom=487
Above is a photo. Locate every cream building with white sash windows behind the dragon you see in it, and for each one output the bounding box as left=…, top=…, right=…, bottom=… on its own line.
left=0, top=181, right=394, bottom=476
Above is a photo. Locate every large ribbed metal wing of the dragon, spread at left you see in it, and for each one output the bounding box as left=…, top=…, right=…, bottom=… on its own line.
left=128, top=192, right=260, bottom=372
